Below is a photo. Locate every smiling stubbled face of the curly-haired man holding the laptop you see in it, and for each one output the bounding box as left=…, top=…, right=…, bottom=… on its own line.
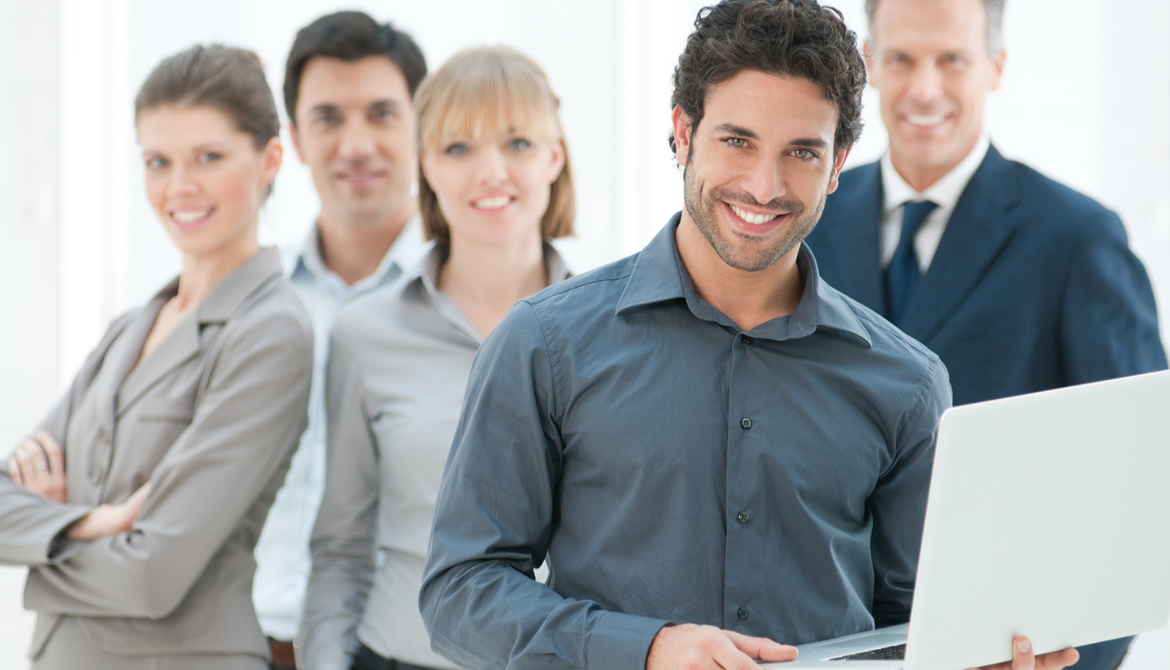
left=674, top=70, right=848, bottom=272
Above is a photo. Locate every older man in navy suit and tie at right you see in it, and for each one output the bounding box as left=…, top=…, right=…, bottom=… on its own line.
left=807, top=0, right=1166, bottom=670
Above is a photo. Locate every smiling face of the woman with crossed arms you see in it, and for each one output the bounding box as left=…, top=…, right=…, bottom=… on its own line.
left=138, top=105, right=281, bottom=258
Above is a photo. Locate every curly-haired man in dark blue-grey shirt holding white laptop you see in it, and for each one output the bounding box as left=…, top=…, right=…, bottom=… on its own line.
left=420, top=0, right=1076, bottom=670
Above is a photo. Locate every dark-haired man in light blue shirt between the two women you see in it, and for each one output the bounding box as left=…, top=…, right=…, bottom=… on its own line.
left=253, top=12, right=427, bottom=668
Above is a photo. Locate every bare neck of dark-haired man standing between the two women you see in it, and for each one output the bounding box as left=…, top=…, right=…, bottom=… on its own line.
left=317, top=198, right=414, bottom=285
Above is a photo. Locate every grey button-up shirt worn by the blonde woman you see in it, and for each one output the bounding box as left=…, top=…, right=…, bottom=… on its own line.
left=298, top=244, right=566, bottom=670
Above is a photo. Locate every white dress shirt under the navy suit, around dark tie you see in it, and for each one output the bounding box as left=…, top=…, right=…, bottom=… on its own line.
left=881, top=133, right=991, bottom=275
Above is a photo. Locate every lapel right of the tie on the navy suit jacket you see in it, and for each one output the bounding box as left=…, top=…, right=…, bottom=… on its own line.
left=902, top=146, right=1020, bottom=346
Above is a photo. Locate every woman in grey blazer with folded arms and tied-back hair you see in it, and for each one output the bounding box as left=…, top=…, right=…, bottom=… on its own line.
left=0, top=46, right=312, bottom=669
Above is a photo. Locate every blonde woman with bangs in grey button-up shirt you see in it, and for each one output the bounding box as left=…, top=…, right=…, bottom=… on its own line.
left=300, top=47, right=574, bottom=670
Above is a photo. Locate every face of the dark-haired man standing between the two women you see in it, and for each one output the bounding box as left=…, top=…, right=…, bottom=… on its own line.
left=293, top=56, right=417, bottom=226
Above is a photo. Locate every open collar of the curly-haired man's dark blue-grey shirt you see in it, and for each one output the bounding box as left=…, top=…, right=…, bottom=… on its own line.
left=617, top=213, right=872, bottom=346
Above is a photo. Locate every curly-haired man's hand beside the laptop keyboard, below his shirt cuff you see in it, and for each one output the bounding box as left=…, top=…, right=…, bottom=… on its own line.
left=646, top=623, right=800, bottom=670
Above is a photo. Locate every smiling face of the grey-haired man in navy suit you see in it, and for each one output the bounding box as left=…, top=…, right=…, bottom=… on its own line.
left=866, top=0, right=1004, bottom=192
